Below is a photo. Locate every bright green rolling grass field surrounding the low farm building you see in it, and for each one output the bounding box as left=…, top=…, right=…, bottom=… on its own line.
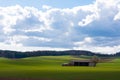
left=0, top=56, right=120, bottom=80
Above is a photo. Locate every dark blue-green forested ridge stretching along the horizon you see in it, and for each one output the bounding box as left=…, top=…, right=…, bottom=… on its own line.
left=0, top=50, right=120, bottom=59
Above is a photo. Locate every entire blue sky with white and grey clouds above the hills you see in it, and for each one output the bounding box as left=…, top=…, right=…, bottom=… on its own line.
left=0, top=0, right=120, bottom=54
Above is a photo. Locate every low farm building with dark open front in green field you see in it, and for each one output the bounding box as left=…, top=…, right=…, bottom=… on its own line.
left=62, top=60, right=96, bottom=67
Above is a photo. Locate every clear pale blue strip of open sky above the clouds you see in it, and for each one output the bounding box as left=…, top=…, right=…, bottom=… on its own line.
left=0, top=0, right=94, bottom=8
